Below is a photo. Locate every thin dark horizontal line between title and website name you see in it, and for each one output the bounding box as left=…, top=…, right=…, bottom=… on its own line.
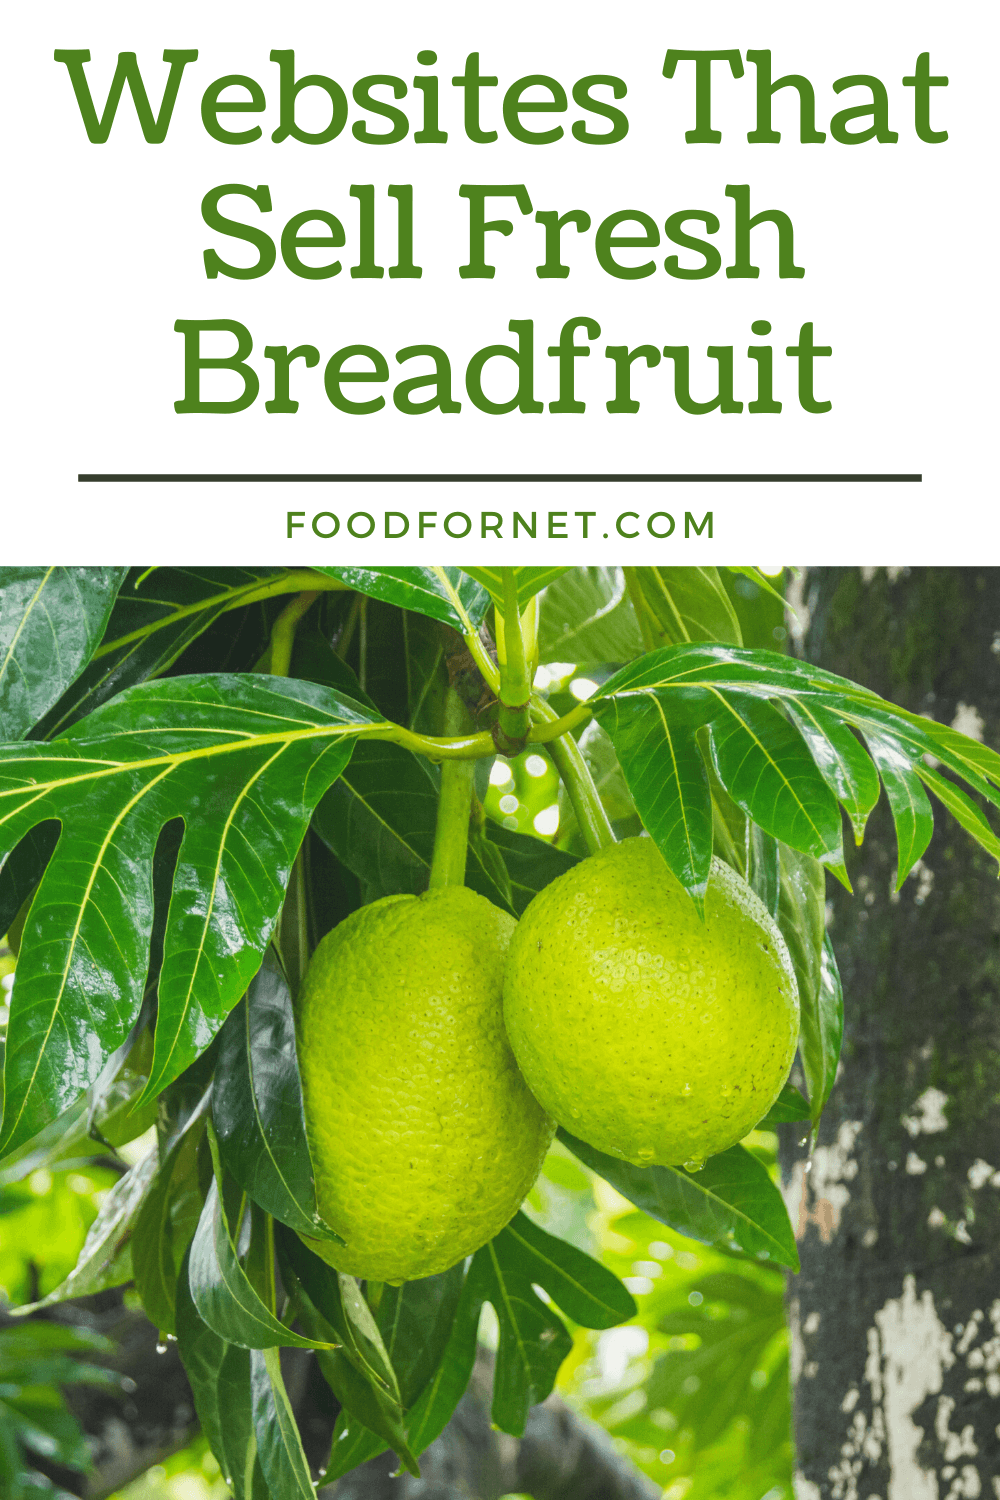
left=76, top=474, right=924, bottom=485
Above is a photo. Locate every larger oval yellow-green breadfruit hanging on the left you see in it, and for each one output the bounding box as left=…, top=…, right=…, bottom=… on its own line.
left=295, top=887, right=555, bottom=1284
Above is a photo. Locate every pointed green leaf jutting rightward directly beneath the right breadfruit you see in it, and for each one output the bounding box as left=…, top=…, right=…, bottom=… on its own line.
left=558, top=1130, right=799, bottom=1271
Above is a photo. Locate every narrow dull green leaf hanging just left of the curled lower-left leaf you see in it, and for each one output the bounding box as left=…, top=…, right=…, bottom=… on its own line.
left=132, top=1115, right=204, bottom=1334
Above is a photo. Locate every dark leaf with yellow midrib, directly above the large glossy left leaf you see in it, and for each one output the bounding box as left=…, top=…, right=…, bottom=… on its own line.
left=33, top=569, right=292, bottom=740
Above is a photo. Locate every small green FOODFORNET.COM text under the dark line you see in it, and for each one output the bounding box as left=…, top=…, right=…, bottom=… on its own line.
left=285, top=510, right=714, bottom=542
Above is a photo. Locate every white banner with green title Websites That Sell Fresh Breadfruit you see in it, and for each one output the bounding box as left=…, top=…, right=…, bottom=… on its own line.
left=1, top=0, right=1000, bottom=566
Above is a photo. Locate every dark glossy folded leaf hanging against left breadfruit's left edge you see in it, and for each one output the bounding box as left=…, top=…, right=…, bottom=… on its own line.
left=211, top=954, right=339, bottom=1239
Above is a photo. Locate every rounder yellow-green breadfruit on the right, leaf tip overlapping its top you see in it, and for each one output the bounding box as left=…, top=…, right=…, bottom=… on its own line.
left=504, top=839, right=799, bottom=1167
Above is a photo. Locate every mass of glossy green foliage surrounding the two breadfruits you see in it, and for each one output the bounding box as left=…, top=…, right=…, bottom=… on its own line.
left=0, top=567, right=1000, bottom=1500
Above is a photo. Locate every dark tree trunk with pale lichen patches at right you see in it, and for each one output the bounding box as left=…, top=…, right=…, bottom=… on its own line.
left=784, top=569, right=1000, bottom=1500
